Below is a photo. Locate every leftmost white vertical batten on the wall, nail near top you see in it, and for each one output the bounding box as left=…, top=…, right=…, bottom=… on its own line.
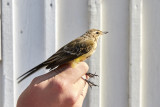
left=0, top=0, right=15, bottom=107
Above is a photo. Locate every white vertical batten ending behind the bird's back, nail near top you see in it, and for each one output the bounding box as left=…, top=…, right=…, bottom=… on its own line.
left=44, top=0, right=57, bottom=58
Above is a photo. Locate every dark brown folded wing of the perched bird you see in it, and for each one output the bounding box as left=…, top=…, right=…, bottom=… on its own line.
left=44, top=39, right=94, bottom=69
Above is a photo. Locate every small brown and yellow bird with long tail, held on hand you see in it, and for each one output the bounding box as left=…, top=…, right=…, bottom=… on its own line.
left=17, top=29, right=108, bottom=86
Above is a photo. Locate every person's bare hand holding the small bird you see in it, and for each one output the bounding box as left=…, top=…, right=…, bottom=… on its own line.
left=17, top=62, right=88, bottom=107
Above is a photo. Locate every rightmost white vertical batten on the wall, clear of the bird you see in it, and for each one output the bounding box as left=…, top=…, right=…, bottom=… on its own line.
left=129, top=0, right=142, bottom=107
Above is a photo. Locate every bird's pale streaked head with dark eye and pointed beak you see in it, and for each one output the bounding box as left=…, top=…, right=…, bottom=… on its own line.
left=86, top=29, right=108, bottom=38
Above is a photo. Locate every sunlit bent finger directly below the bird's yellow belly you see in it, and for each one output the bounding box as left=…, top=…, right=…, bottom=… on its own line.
left=57, top=62, right=89, bottom=83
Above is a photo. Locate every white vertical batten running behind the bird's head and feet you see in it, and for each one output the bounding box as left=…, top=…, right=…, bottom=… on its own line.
left=88, top=0, right=101, bottom=107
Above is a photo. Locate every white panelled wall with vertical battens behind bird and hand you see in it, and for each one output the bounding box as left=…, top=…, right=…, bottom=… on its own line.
left=0, top=0, right=160, bottom=107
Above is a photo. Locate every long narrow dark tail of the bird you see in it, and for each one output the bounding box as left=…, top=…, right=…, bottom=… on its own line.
left=17, top=63, right=45, bottom=83
